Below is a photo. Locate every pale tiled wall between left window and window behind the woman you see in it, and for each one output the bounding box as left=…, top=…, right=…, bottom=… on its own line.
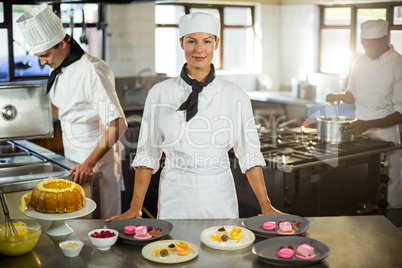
left=107, top=3, right=155, bottom=77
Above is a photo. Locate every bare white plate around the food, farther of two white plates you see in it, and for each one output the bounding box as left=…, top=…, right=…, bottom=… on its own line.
left=200, top=225, right=255, bottom=250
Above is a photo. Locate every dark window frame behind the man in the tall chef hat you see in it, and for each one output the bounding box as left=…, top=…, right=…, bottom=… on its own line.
left=0, top=0, right=107, bottom=83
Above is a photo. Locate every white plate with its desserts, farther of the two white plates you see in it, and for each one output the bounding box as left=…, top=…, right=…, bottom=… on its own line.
left=200, top=225, right=255, bottom=250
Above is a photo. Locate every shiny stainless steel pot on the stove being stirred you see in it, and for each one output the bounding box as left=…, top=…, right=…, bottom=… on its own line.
left=317, top=116, right=356, bottom=143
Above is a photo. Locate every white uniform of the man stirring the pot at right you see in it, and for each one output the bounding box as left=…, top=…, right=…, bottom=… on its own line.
left=347, top=47, right=402, bottom=208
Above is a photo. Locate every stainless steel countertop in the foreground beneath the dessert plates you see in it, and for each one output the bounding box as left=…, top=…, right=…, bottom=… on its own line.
left=0, top=215, right=402, bottom=268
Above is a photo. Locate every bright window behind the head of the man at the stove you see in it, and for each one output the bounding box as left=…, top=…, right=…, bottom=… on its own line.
left=318, top=2, right=402, bottom=74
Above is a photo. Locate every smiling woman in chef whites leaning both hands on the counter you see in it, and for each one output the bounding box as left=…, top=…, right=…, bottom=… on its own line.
left=107, top=13, right=281, bottom=222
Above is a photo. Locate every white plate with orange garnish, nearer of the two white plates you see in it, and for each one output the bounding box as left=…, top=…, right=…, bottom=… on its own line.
left=141, top=240, right=198, bottom=264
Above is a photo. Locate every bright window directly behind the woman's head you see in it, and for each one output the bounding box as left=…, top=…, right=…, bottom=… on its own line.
left=155, top=4, right=255, bottom=73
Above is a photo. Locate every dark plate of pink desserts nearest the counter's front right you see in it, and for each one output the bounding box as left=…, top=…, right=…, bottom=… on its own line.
left=252, top=236, right=330, bottom=266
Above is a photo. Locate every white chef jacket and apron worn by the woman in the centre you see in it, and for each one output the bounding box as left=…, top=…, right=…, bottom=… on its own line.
left=132, top=77, right=265, bottom=219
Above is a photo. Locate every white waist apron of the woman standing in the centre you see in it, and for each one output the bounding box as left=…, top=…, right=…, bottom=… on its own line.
left=158, top=168, right=239, bottom=219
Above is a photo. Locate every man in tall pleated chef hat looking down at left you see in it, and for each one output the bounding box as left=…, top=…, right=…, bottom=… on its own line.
left=17, top=4, right=127, bottom=218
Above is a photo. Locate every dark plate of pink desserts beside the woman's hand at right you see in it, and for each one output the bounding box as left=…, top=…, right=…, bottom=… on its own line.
left=242, top=214, right=310, bottom=238
